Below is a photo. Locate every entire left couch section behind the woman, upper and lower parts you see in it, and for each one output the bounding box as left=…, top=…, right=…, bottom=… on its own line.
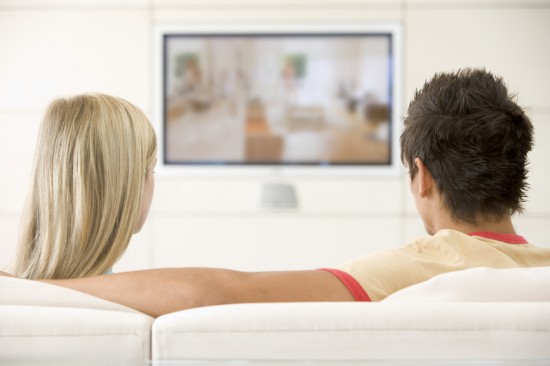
left=0, top=277, right=154, bottom=365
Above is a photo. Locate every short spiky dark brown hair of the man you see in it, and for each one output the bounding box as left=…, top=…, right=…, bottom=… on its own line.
left=401, top=69, right=533, bottom=224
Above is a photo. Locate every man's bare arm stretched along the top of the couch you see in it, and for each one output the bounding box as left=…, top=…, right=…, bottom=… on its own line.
left=42, top=268, right=353, bottom=317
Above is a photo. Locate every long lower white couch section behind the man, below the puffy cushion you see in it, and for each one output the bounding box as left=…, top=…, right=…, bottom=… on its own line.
left=152, top=301, right=550, bottom=364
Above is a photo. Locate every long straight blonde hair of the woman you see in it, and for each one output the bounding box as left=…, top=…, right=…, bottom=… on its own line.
left=15, top=94, right=156, bottom=279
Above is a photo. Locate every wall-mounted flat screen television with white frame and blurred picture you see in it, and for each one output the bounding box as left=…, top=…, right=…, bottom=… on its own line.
left=155, top=25, right=400, bottom=174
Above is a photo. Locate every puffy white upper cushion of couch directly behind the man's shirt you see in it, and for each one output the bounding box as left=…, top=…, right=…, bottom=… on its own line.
left=383, top=267, right=550, bottom=302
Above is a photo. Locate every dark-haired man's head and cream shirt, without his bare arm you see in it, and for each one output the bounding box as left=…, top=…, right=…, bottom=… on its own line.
left=324, top=69, right=550, bottom=301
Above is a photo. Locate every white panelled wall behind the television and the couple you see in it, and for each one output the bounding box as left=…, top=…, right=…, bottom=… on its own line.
left=0, top=0, right=550, bottom=270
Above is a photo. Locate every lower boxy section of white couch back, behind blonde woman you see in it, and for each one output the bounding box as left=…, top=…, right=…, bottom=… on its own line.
left=0, top=305, right=153, bottom=365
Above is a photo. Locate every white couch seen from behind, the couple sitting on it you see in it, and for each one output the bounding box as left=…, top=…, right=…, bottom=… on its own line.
left=0, top=267, right=550, bottom=365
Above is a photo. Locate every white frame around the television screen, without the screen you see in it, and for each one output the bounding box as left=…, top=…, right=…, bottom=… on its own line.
left=153, top=22, right=402, bottom=178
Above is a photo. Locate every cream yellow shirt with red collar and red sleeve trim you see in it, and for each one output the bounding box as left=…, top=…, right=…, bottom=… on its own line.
left=328, top=230, right=550, bottom=301
